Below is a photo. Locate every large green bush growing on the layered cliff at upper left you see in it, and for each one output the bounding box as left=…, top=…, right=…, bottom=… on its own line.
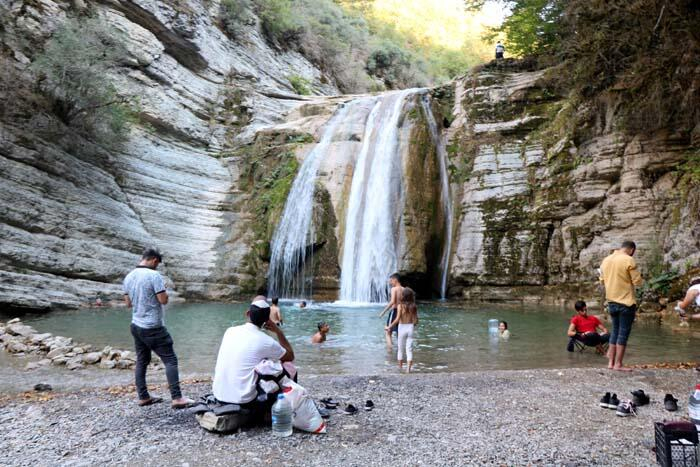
left=32, top=18, right=136, bottom=145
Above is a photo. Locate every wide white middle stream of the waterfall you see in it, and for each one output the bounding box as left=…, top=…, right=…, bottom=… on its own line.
left=340, top=89, right=417, bottom=302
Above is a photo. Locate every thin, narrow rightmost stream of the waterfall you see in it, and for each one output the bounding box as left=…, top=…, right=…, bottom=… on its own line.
left=421, top=94, right=452, bottom=298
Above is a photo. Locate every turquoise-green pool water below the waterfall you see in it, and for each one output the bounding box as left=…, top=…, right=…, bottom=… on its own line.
left=0, top=303, right=700, bottom=375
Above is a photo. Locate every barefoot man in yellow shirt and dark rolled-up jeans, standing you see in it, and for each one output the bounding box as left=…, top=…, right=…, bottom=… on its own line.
left=600, top=240, right=642, bottom=371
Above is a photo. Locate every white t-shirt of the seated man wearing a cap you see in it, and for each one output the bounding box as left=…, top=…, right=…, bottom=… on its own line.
left=212, top=323, right=287, bottom=404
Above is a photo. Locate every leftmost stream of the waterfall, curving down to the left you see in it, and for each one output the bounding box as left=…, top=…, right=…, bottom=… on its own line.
left=268, top=101, right=355, bottom=297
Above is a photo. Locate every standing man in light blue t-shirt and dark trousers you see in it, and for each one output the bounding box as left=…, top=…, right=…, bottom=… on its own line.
left=124, top=248, right=194, bottom=409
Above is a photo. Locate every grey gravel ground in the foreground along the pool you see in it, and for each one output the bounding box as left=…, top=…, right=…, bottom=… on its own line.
left=0, top=369, right=697, bottom=466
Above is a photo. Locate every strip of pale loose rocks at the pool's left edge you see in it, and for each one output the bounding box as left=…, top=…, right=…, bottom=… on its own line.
left=0, top=318, right=162, bottom=370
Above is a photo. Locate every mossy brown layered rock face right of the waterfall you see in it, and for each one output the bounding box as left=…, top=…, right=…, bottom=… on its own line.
left=447, top=69, right=700, bottom=301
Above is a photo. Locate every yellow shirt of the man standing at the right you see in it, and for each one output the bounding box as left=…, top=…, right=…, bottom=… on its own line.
left=600, top=250, right=642, bottom=306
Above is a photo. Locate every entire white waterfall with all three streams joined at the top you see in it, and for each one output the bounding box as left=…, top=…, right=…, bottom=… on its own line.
left=268, top=89, right=453, bottom=303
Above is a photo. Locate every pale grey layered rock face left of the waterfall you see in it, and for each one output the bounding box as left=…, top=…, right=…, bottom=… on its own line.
left=0, top=0, right=336, bottom=309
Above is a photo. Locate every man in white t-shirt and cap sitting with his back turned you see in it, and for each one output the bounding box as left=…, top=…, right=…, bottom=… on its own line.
left=212, top=297, right=294, bottom=410
